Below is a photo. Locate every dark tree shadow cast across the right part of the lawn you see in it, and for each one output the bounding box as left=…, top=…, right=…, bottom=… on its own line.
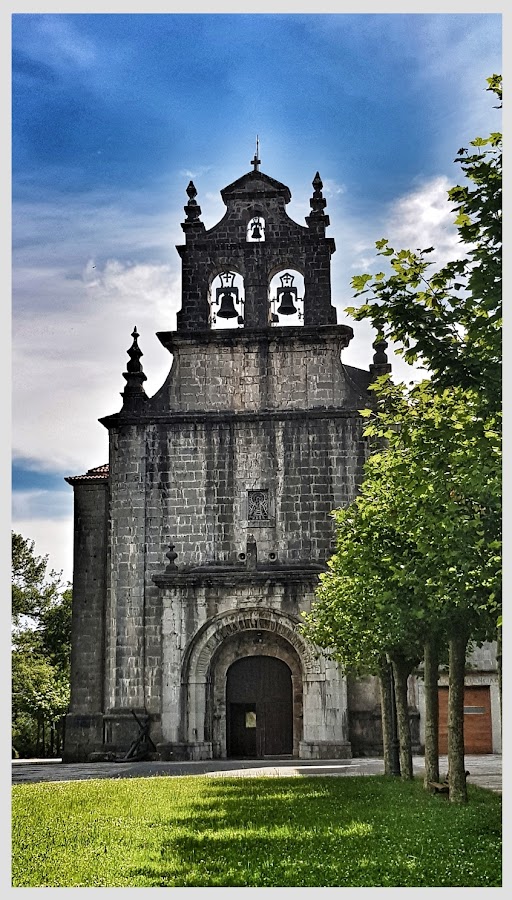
left=126, top=776, right=501, bottom=887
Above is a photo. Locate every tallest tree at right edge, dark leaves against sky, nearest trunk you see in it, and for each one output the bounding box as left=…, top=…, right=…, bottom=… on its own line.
left=352, top=75, right=502, bottom=801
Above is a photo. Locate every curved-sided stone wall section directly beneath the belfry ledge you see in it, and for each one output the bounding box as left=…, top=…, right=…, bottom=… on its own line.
left=154, top=325, right=358, bottom=413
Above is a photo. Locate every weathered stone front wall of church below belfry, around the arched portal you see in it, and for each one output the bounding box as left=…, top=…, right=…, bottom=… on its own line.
left=85, top=326, right=367, bottom=756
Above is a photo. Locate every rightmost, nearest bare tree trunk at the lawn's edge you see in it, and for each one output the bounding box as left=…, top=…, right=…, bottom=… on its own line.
left=448, top=629, right=468, bottom=803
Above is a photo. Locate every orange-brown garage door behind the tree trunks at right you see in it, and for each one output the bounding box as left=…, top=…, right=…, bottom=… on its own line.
left=439, top=685, right=492, bottom=755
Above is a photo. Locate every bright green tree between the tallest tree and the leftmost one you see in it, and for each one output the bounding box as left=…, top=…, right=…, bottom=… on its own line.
left=378, top=382, right=501, bottom=793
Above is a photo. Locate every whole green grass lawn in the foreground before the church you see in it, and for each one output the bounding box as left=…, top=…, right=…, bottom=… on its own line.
left=12, top=776, right=501, bottom=887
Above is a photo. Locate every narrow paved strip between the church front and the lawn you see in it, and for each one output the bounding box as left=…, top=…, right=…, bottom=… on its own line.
left=12, top=754, right=502, bottom=794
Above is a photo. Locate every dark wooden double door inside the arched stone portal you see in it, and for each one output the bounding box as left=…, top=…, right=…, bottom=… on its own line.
left=226, top=656, right=293, bottom=759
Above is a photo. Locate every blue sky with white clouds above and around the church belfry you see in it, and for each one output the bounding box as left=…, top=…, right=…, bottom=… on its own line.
left=12, top=4, right=502, bottom=578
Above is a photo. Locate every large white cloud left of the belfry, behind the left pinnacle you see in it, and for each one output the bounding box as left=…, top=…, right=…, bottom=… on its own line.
left=12, top=259, right=179, bottom=475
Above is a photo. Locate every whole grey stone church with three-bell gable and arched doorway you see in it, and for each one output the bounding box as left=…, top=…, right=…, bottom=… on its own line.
left=65, top=153, right=376, bottom=759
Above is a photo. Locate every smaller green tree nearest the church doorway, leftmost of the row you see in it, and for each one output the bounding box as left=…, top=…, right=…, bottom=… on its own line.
left=303, top=488, right=423, bottom=778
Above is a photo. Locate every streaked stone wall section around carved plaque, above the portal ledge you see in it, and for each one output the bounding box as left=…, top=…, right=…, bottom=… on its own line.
left=146, top=416, right=365, bottom=565
